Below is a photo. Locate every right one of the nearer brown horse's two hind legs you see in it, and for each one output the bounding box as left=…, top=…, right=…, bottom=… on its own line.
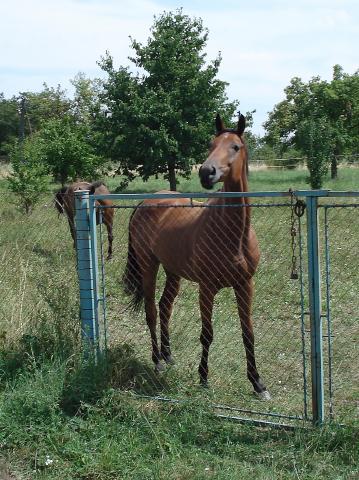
left=159, top=272, right=181, bottom=363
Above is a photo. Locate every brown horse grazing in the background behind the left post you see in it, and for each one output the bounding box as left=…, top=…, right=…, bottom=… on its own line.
left=55, top=182, right=114, bottom=260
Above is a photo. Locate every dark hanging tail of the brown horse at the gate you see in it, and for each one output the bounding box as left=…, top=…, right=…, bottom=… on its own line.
left=122, top=206, right=144, bottom=312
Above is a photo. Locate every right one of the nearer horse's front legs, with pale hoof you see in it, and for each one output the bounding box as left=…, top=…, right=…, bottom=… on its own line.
left=234, top=279, right=270, bottom=400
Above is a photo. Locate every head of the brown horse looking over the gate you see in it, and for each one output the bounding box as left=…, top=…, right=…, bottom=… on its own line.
left=199, top=114, right=247, bottom=189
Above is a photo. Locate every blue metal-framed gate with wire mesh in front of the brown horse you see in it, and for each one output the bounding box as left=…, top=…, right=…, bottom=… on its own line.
left=76, top=191, right=359, bottom=425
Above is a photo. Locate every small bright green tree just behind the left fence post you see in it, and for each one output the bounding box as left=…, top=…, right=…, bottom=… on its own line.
left=40, top=116, right=102, bottom=185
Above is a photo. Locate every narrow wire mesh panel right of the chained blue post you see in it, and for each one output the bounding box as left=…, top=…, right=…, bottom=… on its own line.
left=321, top=204, right=359, bottom=422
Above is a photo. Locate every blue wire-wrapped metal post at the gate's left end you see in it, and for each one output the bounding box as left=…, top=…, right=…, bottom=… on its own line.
left=75, top=190, right=98, bottom=359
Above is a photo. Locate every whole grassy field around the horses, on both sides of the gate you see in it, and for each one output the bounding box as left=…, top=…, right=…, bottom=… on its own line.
left=0, top=168, right=359, bottom=480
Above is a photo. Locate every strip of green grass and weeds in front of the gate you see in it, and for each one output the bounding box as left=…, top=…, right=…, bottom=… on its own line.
left=0, top=362, right=359, bottom=480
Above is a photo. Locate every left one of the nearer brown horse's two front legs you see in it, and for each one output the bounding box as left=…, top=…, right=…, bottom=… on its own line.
left=198, top=285, right=217, bottom=386
